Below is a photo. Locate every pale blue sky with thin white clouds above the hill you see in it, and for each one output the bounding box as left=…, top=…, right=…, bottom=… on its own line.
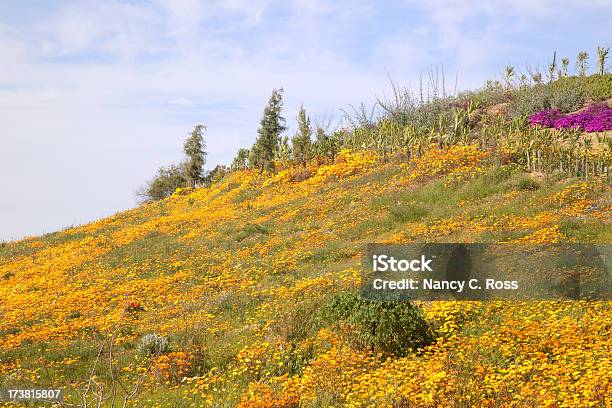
left=0, top=0, right=612, bottom=240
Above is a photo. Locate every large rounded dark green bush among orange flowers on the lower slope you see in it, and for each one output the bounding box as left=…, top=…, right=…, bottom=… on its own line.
left=323, top=292, right=434, bottom=356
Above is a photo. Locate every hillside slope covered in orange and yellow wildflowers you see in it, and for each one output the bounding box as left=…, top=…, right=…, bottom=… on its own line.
left=0, top=145, right=612, bottom=407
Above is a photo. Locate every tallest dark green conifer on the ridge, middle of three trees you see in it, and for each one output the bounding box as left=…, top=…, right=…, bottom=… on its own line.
left=249, top=88, right=287, bottom=171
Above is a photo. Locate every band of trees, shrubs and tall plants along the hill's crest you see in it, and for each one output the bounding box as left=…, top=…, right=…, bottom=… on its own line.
left=139, top=47, right=612, bottom=201
